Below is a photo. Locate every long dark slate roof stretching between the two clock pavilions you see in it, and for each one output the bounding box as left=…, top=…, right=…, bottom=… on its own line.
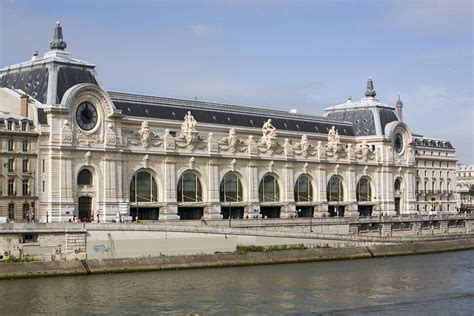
left=108, top=92, right=354, bottom=136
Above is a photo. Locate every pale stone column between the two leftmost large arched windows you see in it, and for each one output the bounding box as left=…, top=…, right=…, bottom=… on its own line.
left=159, top=158, right=179, bottom=220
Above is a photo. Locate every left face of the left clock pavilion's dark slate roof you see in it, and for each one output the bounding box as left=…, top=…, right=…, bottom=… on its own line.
left=0, top=66, right=48, bottom=103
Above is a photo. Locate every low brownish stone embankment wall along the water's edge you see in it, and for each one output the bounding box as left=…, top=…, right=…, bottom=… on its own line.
left=0, top=239, right=474, bottom=279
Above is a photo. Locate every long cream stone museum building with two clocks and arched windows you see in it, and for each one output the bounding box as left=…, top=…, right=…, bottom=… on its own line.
left=0, top=23, right=457, bottom=222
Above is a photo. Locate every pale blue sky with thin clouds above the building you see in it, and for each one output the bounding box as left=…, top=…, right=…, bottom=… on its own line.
left=0, top=0, right=474, bottom=163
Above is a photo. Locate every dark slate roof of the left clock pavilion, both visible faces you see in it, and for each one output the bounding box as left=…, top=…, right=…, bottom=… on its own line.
left=0, top=65, right=97, bottom=104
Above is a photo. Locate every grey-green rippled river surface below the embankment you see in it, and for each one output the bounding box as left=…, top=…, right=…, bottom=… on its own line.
left=0, top=251, right=474, bottom=315
